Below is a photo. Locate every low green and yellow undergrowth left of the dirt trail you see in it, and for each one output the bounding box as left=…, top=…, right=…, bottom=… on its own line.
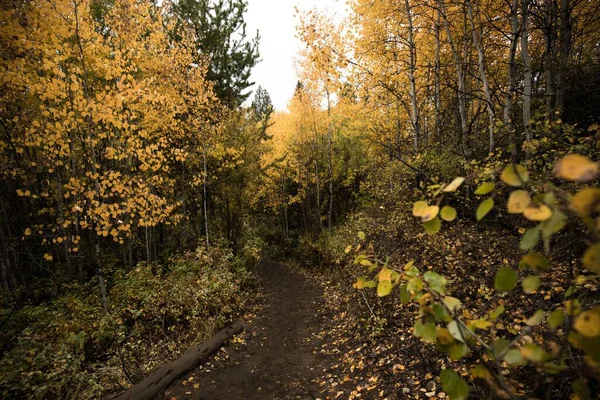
left=0, top=247, right=256, bottom=399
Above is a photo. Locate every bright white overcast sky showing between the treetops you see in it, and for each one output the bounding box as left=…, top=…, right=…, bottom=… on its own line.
left=245, top=0, right=346, bottom=110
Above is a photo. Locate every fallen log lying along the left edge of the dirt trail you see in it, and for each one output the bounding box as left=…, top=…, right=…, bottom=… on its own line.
left=117, top=321, right=245, bottom=400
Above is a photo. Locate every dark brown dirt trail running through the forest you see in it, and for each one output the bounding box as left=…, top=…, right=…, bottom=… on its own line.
left=164, top=261, right=325, bottom=400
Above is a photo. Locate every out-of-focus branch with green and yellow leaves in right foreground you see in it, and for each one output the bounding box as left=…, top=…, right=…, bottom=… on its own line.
left=346, top=154, right=600, bottom=400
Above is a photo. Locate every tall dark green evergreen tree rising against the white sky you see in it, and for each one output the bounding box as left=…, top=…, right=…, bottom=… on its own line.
left=173, top=0, right=260, bottom=108
